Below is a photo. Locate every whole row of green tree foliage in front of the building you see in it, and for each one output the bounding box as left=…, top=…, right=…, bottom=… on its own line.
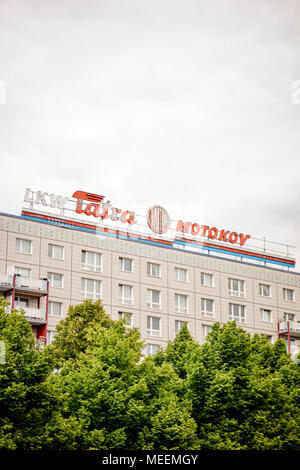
left=0, top=301, right=300, bottom=450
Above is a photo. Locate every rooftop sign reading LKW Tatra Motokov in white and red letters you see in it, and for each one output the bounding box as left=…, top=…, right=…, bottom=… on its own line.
left=22, top=188, right=295, bottom=266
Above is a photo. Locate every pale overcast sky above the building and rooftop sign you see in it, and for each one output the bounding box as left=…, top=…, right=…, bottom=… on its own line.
left=0, top=0, right=300, bottom=264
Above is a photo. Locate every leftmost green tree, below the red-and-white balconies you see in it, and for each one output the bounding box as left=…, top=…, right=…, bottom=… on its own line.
left=0, top=298, right=82, bottom=449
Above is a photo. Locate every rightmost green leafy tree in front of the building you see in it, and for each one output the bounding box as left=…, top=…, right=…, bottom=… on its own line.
left=186, top=323, right=300, bottom=449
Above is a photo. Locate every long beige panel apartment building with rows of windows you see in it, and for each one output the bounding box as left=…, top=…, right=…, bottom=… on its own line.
left=0, top=198, right=300, bottom=356
